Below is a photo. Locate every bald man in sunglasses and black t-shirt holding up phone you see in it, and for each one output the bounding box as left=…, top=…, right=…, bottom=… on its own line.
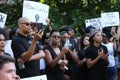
left=11, top=17, right=45, bottom=78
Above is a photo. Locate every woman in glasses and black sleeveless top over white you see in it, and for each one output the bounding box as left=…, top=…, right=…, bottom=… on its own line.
left=44, top=30, right=68, bottom=80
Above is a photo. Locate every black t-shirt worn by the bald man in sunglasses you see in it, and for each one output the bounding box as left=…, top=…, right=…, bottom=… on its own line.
left=11, top=34, right=41, bottom=78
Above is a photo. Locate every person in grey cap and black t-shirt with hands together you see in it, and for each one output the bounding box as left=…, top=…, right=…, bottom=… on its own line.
left=85, top=29, right=109, bottom=80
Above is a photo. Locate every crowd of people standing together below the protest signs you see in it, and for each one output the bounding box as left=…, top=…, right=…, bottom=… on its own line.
left=0, top=17, right=119, bottom=80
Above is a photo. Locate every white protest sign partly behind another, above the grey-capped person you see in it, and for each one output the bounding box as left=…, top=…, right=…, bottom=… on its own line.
left=85, top=18, right=102, bottom=29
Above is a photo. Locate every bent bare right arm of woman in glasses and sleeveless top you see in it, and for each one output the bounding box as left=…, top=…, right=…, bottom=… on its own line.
left=44, top=48, right=68, bottom=68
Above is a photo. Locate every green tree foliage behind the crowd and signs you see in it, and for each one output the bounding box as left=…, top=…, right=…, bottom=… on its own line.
left=0, top=0, right=120, bottom=34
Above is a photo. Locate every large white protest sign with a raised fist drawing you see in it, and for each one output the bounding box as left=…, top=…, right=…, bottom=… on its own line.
left=22, top=1, right=49, bottom=25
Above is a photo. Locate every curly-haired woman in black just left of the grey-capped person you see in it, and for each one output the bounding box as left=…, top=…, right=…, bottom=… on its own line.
left=78, top=35, right=90, bottom=80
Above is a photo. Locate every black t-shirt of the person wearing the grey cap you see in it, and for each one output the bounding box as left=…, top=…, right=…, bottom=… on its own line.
left=85, top=45, right=108, bottom=80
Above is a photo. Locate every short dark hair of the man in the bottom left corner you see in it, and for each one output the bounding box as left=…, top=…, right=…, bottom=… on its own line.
left=0, top=54, right=15, bottom=70
